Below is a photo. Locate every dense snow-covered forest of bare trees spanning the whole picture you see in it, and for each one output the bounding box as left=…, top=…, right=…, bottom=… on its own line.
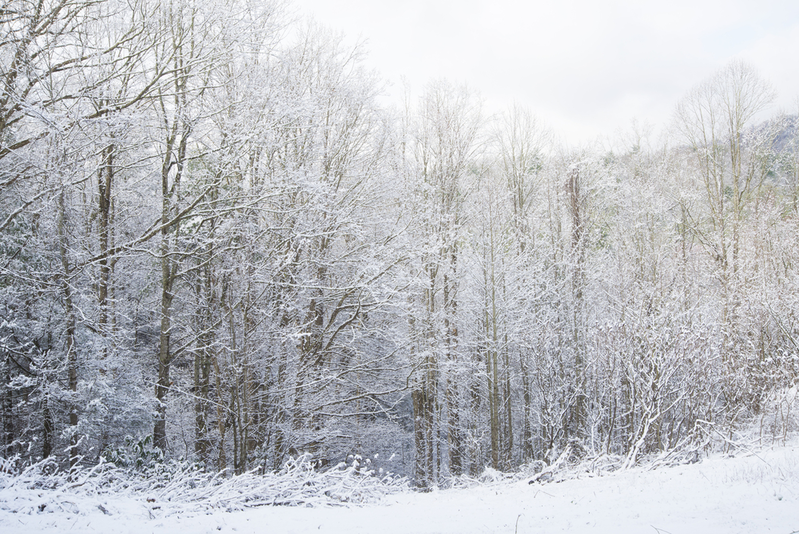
left=0, top=0, right=799, bottom=494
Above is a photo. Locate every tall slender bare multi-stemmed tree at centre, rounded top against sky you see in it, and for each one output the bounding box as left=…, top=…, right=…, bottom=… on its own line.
left=412, top=82, right=480, bottom=485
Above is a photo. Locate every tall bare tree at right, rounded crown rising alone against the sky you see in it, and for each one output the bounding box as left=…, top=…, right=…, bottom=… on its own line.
left=676, top=61, right=775, bottom=420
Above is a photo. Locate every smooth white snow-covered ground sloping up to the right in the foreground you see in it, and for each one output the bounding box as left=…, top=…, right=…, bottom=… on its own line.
left=0, top=442, right=799, bottom=534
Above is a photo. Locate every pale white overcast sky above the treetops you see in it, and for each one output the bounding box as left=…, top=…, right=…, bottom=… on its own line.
left=293, top=0, right=799, bottom=144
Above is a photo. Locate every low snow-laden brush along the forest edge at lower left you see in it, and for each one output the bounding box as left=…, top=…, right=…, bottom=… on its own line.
left=0, top=447, right=409, bottom=513
